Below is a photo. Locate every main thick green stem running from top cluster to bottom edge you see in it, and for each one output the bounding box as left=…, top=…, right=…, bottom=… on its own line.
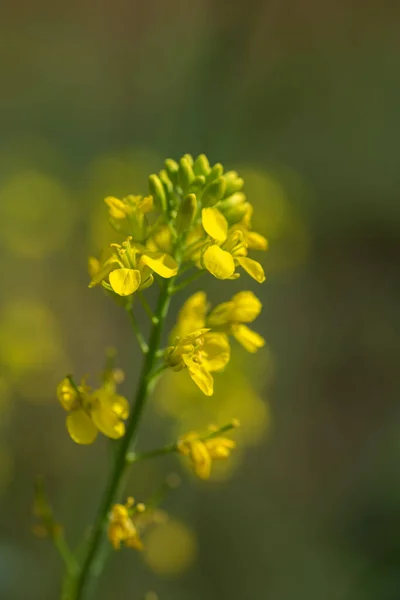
left=69, top=278, right=173, bottom=600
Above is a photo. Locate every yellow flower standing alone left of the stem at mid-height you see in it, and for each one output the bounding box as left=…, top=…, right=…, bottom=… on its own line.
left=57, top=377, right=129, bottom=444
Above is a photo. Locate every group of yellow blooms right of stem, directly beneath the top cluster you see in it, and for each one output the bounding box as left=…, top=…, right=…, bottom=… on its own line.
left=165, top=291, right=265, bottom=396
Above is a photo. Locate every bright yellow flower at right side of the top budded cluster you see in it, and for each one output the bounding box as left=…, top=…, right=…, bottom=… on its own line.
left=201, top=207, right=265, bottom=283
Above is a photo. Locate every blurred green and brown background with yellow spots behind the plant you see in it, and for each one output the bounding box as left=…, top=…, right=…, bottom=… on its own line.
left=0, top=0, right=400, bottom=600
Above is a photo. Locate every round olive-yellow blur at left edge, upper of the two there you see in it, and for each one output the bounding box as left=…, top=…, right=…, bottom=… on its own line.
left=0, top=170, right=73, bottom=259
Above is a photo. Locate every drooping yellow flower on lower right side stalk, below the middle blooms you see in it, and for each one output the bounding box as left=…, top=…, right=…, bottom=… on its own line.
left=177, top=431, right=236, bottom=479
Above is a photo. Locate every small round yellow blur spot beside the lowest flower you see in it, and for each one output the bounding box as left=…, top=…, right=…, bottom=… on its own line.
left=144, top=520, right=197, bottom=576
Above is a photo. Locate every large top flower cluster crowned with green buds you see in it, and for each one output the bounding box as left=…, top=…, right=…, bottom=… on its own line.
left=89, top=154, right=268, bottom=297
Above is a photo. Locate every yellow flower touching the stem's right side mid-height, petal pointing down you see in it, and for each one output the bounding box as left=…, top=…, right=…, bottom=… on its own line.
left=165, top=328, right=230, bottom=396
